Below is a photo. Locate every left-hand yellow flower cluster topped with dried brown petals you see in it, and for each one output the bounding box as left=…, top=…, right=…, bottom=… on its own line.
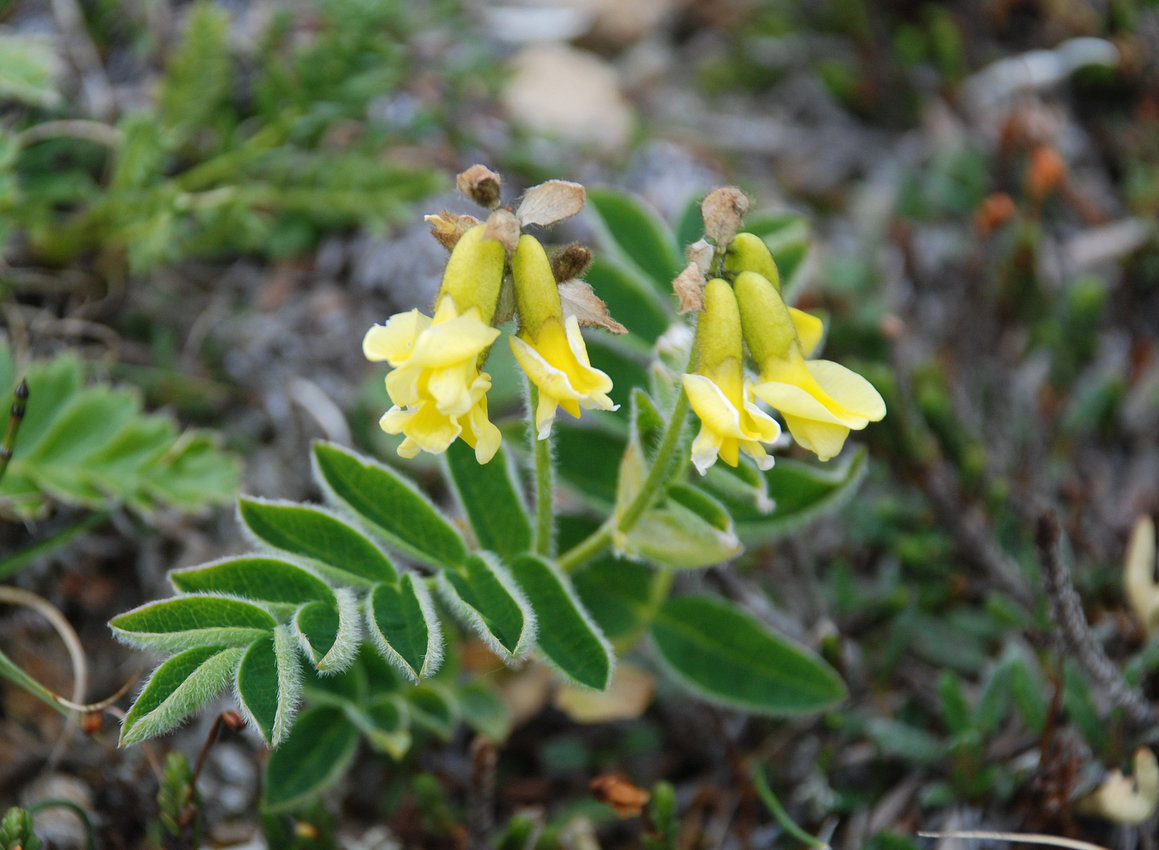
left=363, top=166, right=624, bottom=464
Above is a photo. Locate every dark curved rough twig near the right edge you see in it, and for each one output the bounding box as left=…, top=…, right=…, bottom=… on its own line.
left=1035, top=513, right=1159, bottom=726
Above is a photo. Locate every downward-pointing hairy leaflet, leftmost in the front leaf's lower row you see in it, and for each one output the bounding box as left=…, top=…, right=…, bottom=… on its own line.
left=236, top=626, right=301, bottom=747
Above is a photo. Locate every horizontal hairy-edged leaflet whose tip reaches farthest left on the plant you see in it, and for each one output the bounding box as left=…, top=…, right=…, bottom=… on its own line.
left=109, top=595, right=277, bottom=652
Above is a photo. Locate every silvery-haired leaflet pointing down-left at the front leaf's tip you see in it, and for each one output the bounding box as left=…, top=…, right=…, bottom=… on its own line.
left=119, top=646, right=245, bottom=747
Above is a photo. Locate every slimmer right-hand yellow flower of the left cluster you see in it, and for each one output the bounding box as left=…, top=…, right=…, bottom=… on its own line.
left=510, top=234, right=619, bottom=439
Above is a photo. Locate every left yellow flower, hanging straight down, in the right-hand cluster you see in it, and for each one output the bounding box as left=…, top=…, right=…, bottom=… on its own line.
left=684, top=278, right=781, bottom=475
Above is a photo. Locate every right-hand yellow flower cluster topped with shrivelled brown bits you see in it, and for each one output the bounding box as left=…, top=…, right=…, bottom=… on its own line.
left=676, top=189, right=885, bottom=474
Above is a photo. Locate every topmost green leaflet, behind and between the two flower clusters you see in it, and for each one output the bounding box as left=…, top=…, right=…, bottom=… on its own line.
left=588, top=188, right=684, bottom=289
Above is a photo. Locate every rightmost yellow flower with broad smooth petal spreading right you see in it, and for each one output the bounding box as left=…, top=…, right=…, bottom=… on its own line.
left=735, top=271, right=885, bottom=460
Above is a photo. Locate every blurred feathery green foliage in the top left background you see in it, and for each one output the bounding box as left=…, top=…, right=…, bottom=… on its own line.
left=0, top=0, right=486, bottom=276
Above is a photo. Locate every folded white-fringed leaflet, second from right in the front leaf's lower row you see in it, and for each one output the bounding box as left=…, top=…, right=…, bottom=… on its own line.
left=438, top=552, right=535, bottom=660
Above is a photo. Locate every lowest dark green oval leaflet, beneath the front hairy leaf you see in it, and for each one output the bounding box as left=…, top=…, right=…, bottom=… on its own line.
left=265, top=705, right=358, bottom=812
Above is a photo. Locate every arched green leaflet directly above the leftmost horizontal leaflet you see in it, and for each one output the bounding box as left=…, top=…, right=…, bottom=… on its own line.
left=169, top=555, right=334, bottom=615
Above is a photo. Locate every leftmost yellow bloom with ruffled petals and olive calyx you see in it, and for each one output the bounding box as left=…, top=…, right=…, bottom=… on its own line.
left=363, top=224, right=505, bottom=464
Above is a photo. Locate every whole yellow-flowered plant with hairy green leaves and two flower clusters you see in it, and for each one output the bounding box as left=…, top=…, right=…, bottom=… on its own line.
left=111, top=166, right=884, bottom=808
